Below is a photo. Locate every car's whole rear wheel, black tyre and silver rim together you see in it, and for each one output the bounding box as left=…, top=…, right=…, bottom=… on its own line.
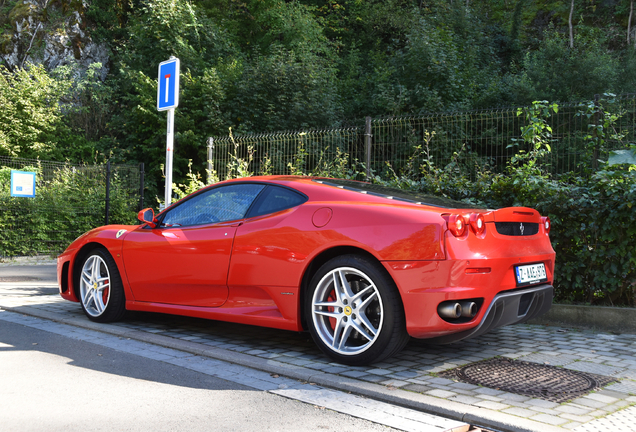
left=305, top=255, right=409, bottom=365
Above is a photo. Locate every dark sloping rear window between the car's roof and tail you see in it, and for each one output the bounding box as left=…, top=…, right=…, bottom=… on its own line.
left=314, top=179, right=481, bottom=209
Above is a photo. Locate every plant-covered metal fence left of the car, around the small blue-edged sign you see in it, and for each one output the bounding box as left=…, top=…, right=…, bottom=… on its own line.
left=0, top=156, right=144, bottom=258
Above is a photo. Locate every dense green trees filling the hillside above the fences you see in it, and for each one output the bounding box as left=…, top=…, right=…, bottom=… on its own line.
left=0, top=0, right=636, bottom=196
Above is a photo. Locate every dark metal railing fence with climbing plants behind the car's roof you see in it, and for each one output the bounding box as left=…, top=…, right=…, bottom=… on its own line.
left=208, top=94, right=636, bottom=180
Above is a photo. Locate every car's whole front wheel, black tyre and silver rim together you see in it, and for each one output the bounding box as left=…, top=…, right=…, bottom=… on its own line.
left=79, top=248, right=126, bottom=322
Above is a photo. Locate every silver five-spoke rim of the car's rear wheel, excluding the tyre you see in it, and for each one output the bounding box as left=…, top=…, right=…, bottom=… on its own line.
left=311, top=267, right=384, bottom=356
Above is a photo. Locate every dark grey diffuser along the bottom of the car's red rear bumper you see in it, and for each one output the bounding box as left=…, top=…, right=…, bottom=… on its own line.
left=426, top=284, right=554, bottom=344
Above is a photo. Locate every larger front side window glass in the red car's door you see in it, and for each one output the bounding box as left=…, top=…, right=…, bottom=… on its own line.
left=161, top=183, right=265, bottom=226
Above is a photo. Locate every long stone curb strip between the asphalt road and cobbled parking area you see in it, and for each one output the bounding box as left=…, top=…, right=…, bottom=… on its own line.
left=2, top=306, right=565, bottom=432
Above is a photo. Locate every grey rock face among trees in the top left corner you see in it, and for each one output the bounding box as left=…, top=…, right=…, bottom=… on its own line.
left=0, top=0, right=109, bottom=79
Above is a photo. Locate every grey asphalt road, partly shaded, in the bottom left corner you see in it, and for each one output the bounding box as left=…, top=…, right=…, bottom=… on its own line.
left=0, top=321, right=392, bottom=432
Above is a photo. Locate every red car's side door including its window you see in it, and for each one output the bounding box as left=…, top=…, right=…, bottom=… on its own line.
left=123, top=183, right=264, bottom=307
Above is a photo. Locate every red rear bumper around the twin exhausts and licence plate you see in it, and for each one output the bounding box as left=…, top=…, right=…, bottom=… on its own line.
left=383, top=252, right=554, bottom=342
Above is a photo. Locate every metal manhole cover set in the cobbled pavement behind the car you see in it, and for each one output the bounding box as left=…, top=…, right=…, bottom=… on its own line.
left=439, top=358, right=616, bottom=403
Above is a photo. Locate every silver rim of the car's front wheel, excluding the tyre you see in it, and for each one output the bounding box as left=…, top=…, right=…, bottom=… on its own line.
left=80, top=255, right=110, bottom=317
